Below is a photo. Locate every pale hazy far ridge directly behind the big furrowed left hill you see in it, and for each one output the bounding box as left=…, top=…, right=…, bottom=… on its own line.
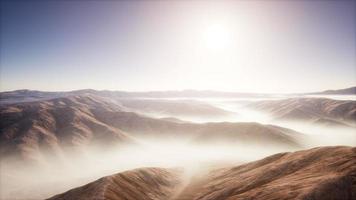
left=0, top=89, right=233, bottom=118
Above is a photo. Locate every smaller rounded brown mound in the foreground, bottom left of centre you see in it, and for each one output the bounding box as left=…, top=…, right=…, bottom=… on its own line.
left=50, top=168, right=181, bottom=200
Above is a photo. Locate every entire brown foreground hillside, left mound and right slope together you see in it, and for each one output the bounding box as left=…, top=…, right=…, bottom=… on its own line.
left=50, top=147, right=356, bottom=200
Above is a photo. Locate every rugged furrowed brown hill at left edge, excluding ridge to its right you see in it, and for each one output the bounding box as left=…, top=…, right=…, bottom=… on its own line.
left=0, top=96, right=133, bottom=160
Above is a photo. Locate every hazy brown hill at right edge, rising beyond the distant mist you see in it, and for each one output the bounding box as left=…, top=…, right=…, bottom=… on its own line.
left=248, top=98, right=356, bottom=124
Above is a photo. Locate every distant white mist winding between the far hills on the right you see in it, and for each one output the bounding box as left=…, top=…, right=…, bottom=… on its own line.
left=142, top=95, right=356, bottom=147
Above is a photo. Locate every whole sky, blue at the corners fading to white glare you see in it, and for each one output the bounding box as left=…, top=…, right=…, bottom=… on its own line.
left=0, top=0, right=356, bottom=93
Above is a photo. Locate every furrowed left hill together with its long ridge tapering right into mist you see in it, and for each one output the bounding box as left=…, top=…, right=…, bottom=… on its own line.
left=0, top=95, right=300, bottom=163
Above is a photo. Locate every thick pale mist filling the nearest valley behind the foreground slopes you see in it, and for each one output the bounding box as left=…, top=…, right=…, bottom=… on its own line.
left=0, top=138, right=295, bottom=199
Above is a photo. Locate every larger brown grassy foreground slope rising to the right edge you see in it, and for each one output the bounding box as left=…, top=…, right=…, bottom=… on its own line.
left=194, top=147, right=356, bottom=200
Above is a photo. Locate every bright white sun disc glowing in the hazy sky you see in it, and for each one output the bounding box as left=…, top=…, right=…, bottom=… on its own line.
left=203, top=22, right=231, bottom=50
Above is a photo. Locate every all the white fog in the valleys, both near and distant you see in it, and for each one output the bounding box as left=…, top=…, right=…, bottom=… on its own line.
left=0, top=96, right=356, bottom=199
